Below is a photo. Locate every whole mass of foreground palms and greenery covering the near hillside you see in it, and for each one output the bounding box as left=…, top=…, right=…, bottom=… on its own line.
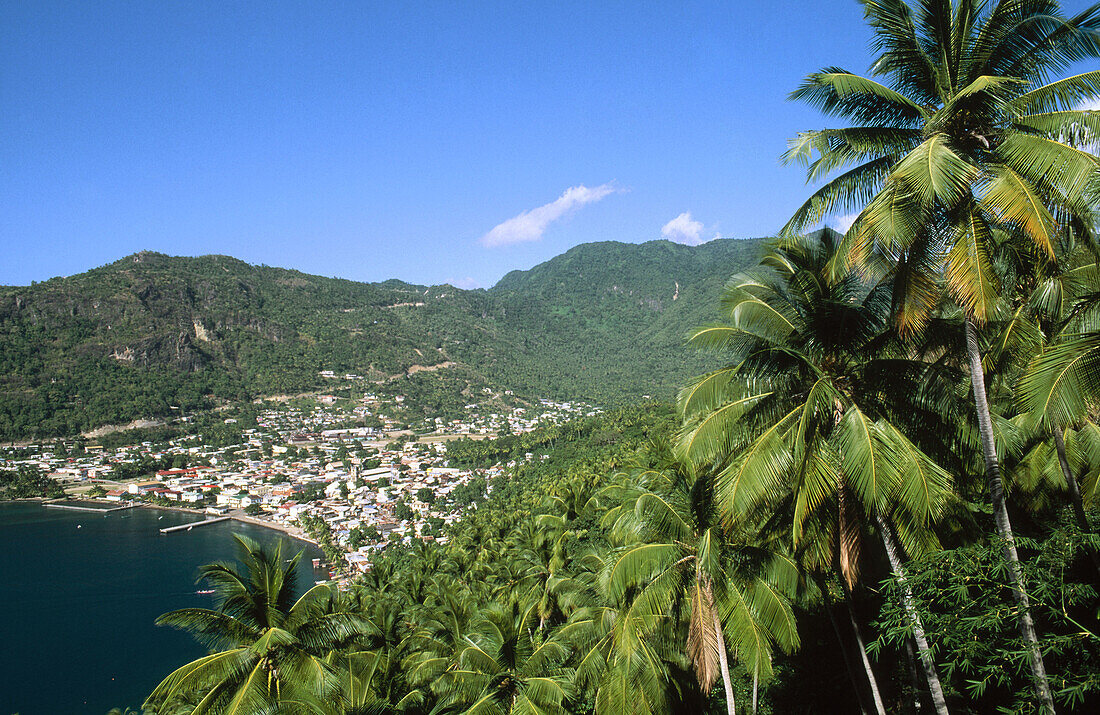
left=99, top=0, right=1100, bottom=715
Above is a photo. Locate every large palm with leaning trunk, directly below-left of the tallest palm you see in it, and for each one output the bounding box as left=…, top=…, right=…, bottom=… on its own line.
left=679, top=230, right=950, bottom=712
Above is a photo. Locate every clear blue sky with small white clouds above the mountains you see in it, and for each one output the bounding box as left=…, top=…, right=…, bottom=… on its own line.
left=0, top=0, right=1084, bottom=287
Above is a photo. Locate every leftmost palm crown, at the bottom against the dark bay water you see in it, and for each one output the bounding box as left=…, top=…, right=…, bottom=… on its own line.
left=145, top=536, right=370, bottom=714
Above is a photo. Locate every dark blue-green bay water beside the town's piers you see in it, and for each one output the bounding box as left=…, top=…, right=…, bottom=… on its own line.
left=0, top=503, right=326, bottom=715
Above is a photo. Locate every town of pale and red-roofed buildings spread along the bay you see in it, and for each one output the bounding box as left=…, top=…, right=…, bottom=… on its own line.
left=0, top=385, right=601, bottom=574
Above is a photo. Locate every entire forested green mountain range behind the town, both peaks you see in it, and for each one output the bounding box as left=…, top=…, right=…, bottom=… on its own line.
left=0, top=239, right=760, bottom=439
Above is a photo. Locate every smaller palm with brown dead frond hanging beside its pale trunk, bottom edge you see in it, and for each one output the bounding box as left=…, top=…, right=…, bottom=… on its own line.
left=607, top=447, right=799, bottom=715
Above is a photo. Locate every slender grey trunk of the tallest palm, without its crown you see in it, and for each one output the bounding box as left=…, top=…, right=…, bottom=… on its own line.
left=963, top=318, right=1055, bottom=715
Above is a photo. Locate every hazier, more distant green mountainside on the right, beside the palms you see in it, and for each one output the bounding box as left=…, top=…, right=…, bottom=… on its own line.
left=490, top=239, right=760, bottom=403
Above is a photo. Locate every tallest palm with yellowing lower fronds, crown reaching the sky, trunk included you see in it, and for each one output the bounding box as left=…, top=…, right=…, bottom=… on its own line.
left=784, top=0, right=1100, bottom=712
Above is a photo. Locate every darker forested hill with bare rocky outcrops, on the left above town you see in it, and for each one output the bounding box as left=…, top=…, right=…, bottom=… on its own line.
left=0, top=253, right=495, bottom=437
